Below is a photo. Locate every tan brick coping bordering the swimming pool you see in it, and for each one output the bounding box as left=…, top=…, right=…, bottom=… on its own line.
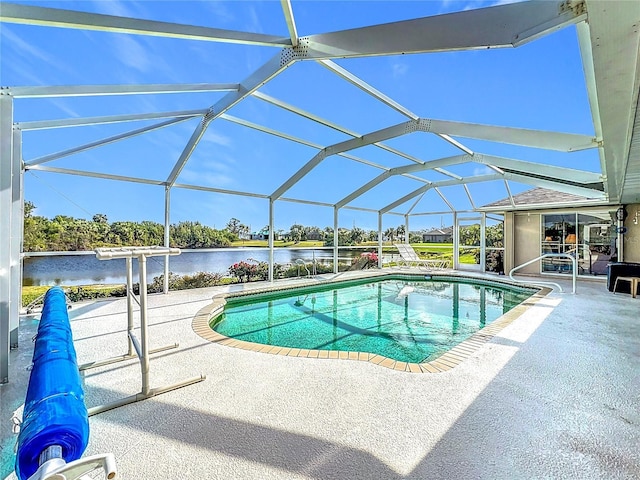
left=191, top=271, right=552, bottom=373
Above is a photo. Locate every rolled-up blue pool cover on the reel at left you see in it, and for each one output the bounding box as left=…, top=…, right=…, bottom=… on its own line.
left=16, top=287, right=89, bottom=480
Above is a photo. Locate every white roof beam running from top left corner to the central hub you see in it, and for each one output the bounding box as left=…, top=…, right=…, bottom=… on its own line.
left=0, top=3, right=291, bottom=47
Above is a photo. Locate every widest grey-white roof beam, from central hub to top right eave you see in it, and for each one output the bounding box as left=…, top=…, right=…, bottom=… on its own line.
left=307, top=1, right=588, bottom=59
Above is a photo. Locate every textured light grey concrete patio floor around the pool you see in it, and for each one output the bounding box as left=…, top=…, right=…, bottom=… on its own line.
left=0, top=272, right=640, bottom=480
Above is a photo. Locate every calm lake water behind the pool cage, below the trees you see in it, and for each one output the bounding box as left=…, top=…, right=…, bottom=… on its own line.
left=22, top=247, right=374, bottom=286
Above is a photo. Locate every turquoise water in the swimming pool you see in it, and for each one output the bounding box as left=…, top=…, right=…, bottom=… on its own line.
left=211, top=277, right=534, bottom=363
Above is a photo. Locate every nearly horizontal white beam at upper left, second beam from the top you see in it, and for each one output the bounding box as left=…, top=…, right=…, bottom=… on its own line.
left=10, top=83, right=240, bottom=98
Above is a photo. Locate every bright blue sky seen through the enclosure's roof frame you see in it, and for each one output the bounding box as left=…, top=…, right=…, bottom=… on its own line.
left=0, top=0, right=599, bottom=230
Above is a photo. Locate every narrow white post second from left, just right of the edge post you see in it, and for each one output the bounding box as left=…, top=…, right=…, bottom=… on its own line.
left=9, top=129, right=24, bottom=348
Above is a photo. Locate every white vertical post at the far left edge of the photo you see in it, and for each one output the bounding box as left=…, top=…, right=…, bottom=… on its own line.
left=0, top=89, right=13, bottom=384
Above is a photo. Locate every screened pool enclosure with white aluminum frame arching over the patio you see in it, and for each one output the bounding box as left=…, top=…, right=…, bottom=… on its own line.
left=0, top=0, right=640, bottom=383
